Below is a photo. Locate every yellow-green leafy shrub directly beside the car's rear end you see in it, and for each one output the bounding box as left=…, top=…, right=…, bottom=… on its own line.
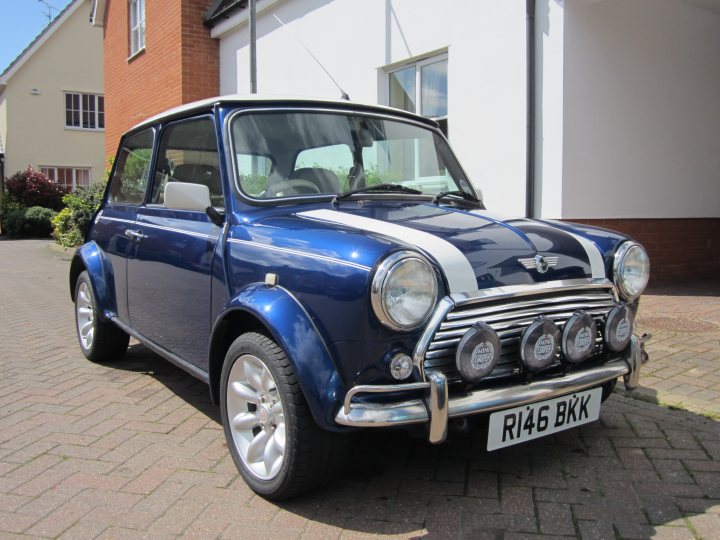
left=52, top=183, right=105, bottom=248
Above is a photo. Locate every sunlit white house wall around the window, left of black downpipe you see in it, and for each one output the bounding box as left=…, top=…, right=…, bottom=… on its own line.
left=213, top=0, right=526, bottom=215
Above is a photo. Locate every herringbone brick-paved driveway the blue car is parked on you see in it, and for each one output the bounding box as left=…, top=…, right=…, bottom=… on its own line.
left=0, top=241, right=720, bottom=539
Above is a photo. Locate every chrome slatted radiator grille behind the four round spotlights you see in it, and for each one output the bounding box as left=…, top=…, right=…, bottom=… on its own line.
left=424, top=283, right=615, bottom=379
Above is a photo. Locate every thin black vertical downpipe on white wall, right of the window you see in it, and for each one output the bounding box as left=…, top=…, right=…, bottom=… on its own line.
left=525, top=0, right=536, bottom=218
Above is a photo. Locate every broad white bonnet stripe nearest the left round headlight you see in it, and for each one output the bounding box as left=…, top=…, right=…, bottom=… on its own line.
left=298, top=210, right=478, bottom=294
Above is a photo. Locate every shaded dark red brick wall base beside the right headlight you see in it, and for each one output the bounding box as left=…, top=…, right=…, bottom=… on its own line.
left=568, top=218, right=720, bottom=283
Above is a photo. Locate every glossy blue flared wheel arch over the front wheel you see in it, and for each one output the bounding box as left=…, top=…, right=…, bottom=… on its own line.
left=208, top=284, right=345, bottom=431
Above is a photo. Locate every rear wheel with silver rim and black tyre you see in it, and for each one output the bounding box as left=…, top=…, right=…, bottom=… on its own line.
left=75, top=271, right=130, bottom=362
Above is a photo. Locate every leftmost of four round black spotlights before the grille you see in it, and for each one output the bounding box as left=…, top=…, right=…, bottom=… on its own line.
left=455, top=323, right=501, bottom=382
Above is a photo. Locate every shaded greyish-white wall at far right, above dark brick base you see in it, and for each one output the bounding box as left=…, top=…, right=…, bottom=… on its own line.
left=564, top=0, right=720, bottom=218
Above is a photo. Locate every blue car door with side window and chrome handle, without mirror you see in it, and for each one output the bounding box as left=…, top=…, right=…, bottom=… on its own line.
left=128, top=116, right=224, bottom=371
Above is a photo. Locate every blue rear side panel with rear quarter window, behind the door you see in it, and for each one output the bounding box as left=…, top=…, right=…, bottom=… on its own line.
left=93, top=128, right=154, bottom=324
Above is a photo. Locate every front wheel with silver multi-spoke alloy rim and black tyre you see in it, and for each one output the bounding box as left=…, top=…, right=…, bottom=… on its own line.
left=220, top=333, right=348, bottom=500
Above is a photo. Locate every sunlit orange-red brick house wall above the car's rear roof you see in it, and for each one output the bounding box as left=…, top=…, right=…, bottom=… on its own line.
left=104, top=0, right=220, bottom=156
